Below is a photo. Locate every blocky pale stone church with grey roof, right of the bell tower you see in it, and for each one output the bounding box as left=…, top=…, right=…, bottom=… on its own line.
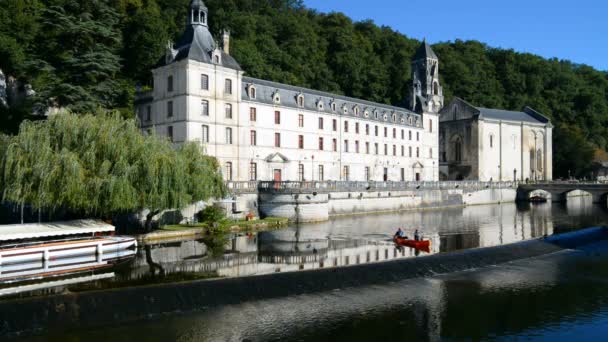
left=439, top=98, right=553, bottom=181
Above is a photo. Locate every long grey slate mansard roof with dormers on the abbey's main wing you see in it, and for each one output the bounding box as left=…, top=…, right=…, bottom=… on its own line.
left=241, top=77, right=422, bottom=127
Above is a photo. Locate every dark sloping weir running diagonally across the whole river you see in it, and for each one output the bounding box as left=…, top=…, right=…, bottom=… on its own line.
left=0, top=228, right=608, bottom=335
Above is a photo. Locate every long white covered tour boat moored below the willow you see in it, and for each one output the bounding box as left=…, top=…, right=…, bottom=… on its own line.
left=0, top=220, right=137, bottom=265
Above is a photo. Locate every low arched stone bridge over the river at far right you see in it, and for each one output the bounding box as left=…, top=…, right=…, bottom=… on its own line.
left=517, top=182, right=608, bottom=204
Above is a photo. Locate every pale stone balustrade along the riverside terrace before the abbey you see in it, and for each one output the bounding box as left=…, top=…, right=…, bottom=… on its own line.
left=227, top=181, right=518, bottom=194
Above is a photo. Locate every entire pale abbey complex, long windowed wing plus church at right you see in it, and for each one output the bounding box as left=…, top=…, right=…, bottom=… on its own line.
left=136, top=0, right=552, bottom=181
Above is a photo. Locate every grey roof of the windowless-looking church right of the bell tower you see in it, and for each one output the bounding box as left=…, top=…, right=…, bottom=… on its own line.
left=440, top=97, right=551, bottom=126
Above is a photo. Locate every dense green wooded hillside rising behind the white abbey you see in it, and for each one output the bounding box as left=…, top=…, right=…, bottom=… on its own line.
left=0, top=0, right=608, bottom=176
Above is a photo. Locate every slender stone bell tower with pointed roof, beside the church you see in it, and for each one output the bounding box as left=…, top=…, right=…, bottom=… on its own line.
left=410, top=40, right=443, bottom=113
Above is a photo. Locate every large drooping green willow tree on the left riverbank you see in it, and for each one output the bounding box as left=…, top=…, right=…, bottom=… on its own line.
left=0, top=113, right=224, bottom=226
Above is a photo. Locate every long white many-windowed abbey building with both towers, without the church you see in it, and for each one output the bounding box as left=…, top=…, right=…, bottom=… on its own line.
left=136, top=0, right=443, bottom=181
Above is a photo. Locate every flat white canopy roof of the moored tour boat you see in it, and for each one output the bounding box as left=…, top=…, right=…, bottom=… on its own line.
left=0, top=220, right=114, bottom=242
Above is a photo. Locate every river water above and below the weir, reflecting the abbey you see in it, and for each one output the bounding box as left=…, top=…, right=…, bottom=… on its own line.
left=5, top=198, right=608, bottom=341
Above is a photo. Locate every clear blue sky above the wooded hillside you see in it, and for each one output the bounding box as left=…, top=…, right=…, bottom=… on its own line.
left=304, top=0, right=608, bottom=70
